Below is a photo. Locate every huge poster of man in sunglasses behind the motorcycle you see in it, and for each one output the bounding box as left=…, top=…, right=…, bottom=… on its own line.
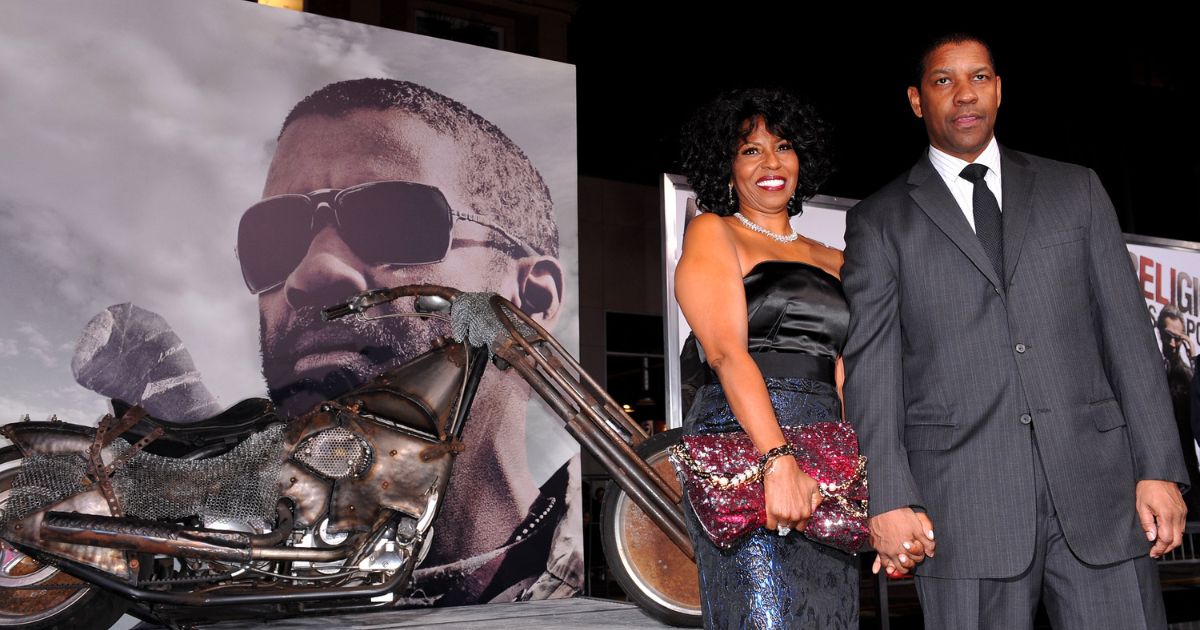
left=0, top=0, right=582, bottom=605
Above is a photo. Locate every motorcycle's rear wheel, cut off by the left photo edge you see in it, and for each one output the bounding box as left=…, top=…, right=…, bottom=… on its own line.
left=0, top=446, right=130, bottom=630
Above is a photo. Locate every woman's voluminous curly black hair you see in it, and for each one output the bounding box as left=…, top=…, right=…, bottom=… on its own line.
left=679, top=89, right=833, bottom=216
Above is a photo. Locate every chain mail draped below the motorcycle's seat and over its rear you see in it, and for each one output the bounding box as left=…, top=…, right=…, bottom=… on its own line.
left=2, top=424, right=284, bottom=529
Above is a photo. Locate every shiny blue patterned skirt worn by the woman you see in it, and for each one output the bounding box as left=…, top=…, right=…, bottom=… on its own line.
left=684, top=378, right=858, bottom=630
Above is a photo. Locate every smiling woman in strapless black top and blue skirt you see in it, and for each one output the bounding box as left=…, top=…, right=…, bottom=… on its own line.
left=676, top=90, right=916, bottom=629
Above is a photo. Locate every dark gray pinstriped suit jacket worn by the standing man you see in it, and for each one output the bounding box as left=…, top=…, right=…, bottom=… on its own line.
left=842, top=149, right=1188, bottom=577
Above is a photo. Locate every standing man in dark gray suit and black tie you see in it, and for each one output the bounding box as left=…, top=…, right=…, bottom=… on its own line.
left=842, top=36, right=1187, bottom=630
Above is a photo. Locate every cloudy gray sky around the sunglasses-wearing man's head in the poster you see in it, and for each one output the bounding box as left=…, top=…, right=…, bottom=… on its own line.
left=0, top=0, right=578, bottom=470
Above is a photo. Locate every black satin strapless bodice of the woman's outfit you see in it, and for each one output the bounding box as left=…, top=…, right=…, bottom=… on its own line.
left=743, top=260, right=850, bottom=360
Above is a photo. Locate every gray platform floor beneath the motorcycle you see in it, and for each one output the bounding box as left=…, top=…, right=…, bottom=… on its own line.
left=136, top=598, right=670, bottom=630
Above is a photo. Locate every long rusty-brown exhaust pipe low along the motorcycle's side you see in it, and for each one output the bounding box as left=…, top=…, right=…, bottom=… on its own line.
left=40, top=512, right=352, bottom=563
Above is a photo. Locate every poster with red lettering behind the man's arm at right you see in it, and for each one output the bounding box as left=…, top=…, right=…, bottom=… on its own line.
left=1127, top=236, right=1200, bottom=521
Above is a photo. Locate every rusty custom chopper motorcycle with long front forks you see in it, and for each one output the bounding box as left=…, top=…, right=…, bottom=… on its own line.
left=0, top=286, right=700, bottom=629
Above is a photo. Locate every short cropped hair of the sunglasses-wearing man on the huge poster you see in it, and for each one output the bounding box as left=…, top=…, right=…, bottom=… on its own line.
left=280, top=78, right=558, bottom=258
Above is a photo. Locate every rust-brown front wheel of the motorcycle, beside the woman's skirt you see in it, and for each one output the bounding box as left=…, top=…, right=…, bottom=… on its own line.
left=600, top=428, right=702, bottom=628
